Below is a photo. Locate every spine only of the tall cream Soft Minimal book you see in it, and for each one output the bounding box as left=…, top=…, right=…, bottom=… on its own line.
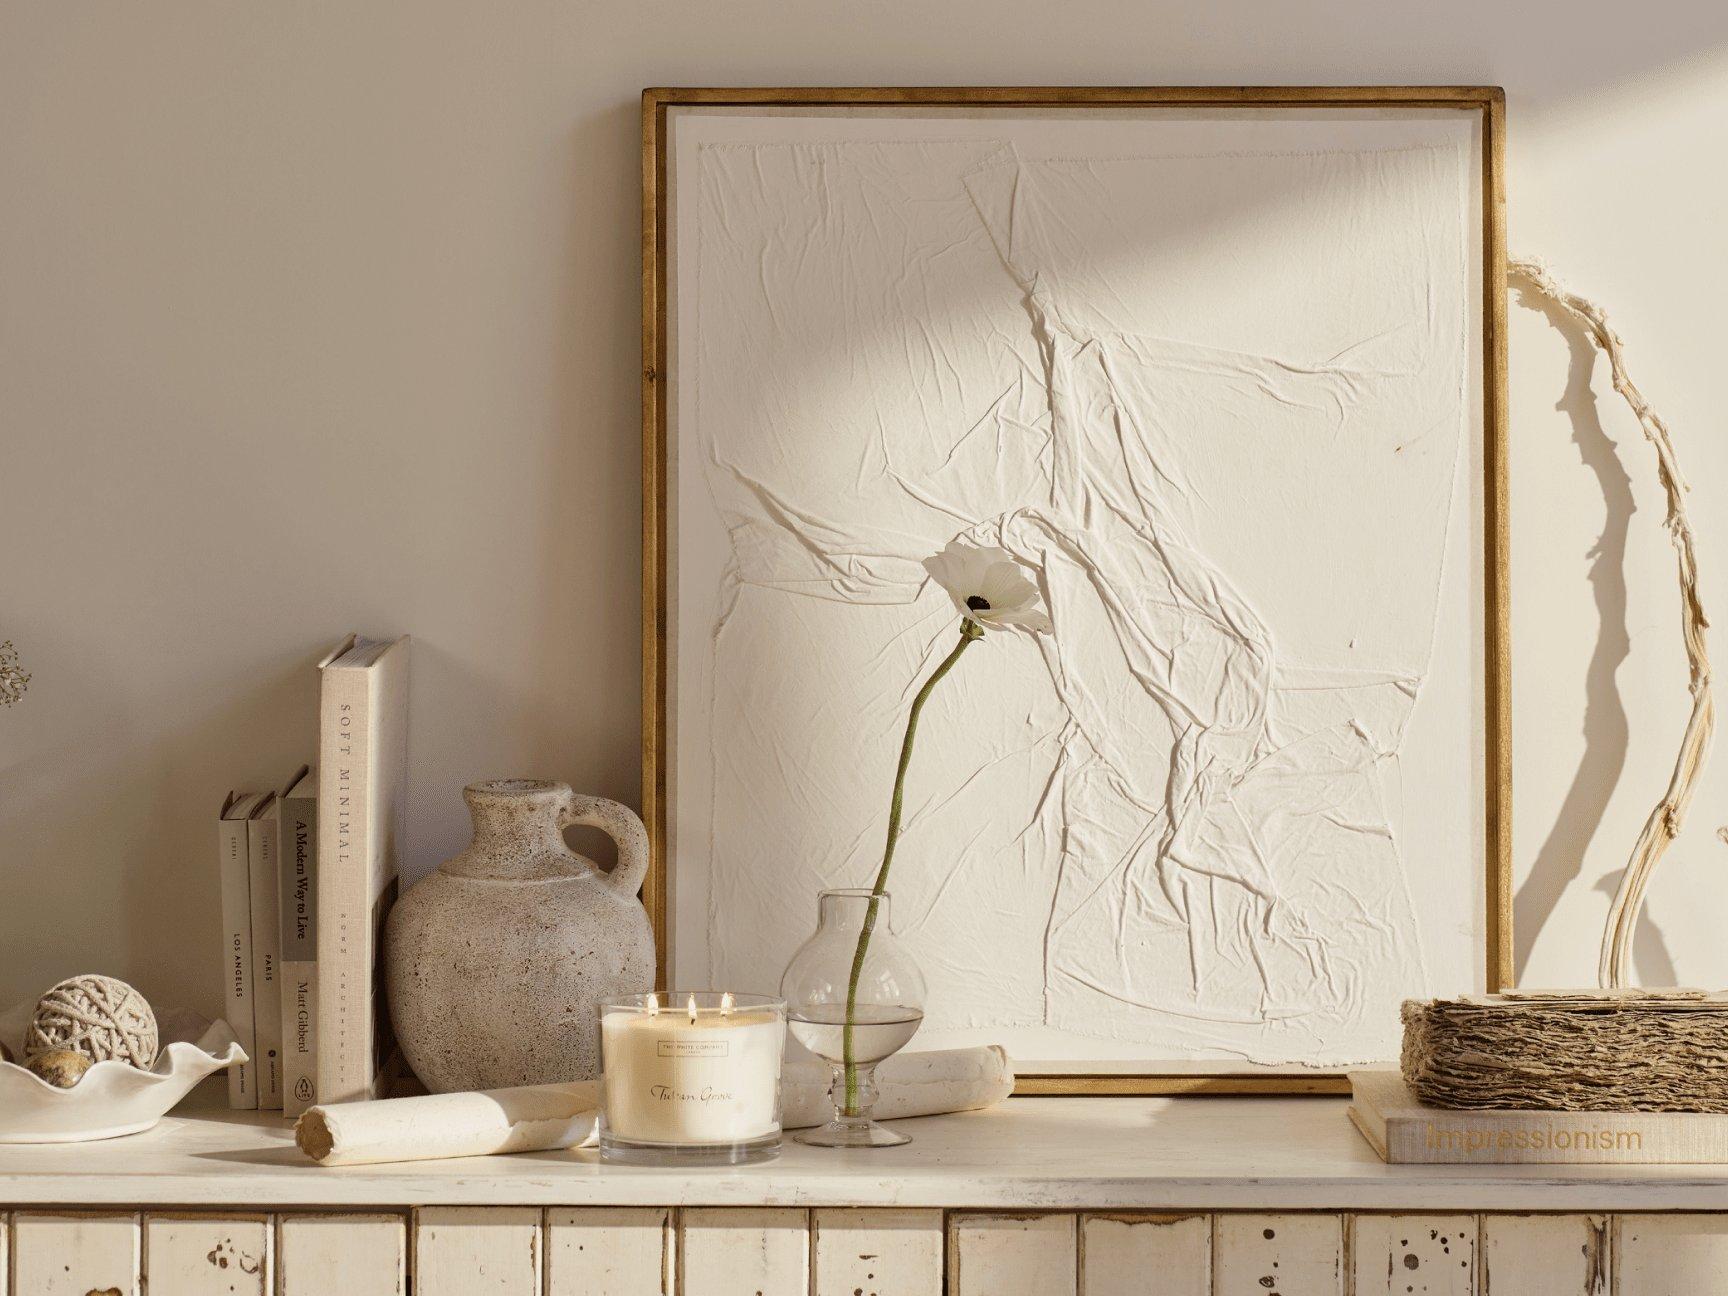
left=316, top=667, right=373, bottom=1102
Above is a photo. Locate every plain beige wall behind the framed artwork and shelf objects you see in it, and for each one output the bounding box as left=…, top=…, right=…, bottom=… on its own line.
left=0, top=0, right=1728, bottom=1011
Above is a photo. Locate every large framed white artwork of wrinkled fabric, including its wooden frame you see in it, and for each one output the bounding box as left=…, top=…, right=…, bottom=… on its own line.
left=643, top=86, right=1510, bottom=1092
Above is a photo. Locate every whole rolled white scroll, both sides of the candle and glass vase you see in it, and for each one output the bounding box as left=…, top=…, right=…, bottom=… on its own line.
left=294, top=1044, right=1014, bottom=1166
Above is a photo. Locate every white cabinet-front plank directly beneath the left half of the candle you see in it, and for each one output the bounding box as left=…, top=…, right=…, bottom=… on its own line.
left=546, top=1206, right=676, bottom=1296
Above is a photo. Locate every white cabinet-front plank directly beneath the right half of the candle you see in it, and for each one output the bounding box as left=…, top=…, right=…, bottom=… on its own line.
left=677, top=1206, right=810, bottom=1296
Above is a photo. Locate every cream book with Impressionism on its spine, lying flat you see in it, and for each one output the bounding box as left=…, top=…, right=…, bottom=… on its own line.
left=1350, top=1071, right=1728, bottom=1165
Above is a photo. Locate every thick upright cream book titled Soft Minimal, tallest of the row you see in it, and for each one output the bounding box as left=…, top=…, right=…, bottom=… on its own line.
left=314, top=636, right=408, bottom=1102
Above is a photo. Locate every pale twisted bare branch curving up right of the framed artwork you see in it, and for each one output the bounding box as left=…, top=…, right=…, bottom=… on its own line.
left=1509, top=257, right=1728, bottom=990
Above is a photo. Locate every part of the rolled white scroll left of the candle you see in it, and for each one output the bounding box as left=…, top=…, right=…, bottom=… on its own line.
left=294, top=1082, right=600, bottom=1165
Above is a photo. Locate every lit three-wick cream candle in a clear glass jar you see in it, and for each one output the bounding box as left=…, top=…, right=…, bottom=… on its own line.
left=600, top=1007, right=786, bottom=1144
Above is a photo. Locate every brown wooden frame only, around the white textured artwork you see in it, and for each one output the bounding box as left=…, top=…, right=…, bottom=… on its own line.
left=641, top=86, right=1512, bottom=1094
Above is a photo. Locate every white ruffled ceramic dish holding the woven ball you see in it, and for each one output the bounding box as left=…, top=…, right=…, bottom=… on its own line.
left=0, top=1021, right=245, bottom=1144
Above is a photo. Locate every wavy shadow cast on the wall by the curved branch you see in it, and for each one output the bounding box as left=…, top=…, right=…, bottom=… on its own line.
left=1512, top=280, right=1676, bottom=985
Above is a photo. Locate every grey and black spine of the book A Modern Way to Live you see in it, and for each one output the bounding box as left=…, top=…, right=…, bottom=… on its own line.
left=278, top=797, right=318, bottom=1116
